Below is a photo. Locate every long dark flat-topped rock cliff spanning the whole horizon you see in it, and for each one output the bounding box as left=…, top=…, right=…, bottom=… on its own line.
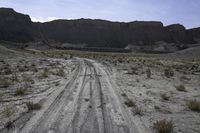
left=0, top=8, right=196, bottom=48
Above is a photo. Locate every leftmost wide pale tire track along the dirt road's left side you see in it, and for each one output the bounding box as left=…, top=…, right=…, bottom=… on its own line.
left=19, top=59, right=84, bottom=133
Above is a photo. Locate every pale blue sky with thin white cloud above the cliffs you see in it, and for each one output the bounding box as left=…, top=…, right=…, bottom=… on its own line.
left=0, top=0, right=200, bottom=28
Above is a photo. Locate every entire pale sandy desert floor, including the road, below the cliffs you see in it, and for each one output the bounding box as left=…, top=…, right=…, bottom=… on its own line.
left=0, top=46, right=200, bottom=133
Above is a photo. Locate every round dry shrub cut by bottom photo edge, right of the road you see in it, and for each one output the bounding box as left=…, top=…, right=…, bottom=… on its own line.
left=153, top=119, right=174, bottom=133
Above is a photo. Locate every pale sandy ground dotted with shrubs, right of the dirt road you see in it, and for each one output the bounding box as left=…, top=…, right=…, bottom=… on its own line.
left=113, top=56, right=200, bottom=133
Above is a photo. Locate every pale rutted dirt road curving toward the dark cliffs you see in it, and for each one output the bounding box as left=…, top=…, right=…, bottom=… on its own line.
left=2, top=58, right=147, bottom=133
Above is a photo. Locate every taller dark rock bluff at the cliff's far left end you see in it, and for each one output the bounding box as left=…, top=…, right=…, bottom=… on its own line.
left=0, top=8, right=34, bottom=42
